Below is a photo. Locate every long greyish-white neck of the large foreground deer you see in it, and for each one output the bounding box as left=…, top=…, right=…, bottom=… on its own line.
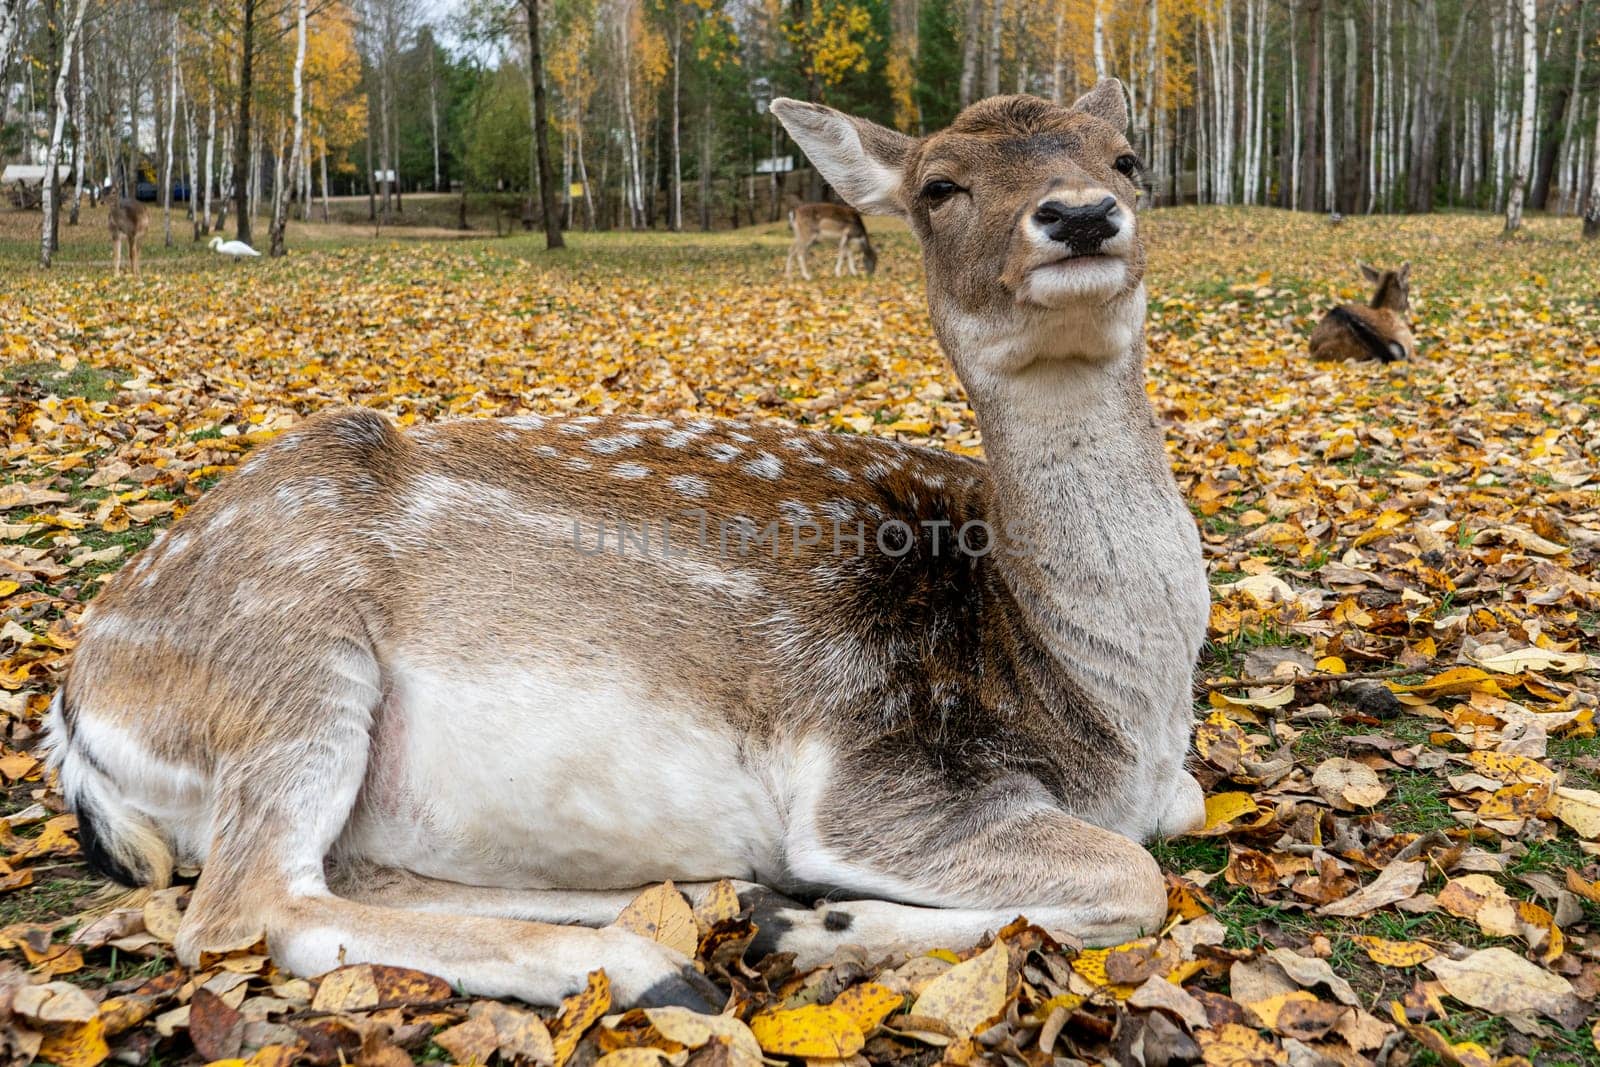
left=947, top=293, right=1208, bottom=718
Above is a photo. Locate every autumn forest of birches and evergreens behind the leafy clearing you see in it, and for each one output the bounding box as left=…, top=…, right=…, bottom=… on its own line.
left=0, top=0, right=1600, bottom=261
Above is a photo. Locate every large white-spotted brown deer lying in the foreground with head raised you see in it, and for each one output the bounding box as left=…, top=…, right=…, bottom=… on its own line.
left=48, top=80, right=1208, bottom=1005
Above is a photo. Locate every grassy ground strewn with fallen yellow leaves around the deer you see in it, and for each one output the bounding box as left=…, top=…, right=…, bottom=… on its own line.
left=0, top=210, right=1600, bottom=1067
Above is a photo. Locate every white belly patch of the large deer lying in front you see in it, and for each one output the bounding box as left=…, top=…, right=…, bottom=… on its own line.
left=341, top=667, right=782, bottom=889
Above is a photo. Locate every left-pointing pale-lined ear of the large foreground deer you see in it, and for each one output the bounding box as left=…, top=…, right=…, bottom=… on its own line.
left=773, top=98, right=915, bottom=214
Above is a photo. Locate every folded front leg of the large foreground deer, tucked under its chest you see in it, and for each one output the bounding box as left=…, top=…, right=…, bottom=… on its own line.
left=762, top=745, right=1166, bottom=963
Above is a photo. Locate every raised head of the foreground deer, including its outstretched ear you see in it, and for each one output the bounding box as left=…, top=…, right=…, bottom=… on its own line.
left=773, top=78, right=1144, bottom=378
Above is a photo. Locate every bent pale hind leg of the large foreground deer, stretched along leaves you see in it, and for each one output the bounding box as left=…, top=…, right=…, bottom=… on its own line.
left=178, top=664, right=720, bottom=1011
